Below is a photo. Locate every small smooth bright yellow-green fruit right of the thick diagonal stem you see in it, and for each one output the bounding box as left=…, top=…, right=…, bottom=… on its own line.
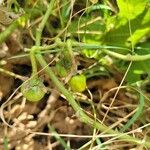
left=69, top=74, right=86, bottom=92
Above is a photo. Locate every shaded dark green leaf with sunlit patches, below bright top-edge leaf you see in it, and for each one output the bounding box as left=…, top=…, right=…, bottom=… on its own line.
left=102, top=8, right=150, bottom=47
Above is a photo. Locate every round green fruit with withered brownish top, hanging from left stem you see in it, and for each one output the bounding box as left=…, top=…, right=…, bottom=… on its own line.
left=21, top=78, right=46, bottom=102
